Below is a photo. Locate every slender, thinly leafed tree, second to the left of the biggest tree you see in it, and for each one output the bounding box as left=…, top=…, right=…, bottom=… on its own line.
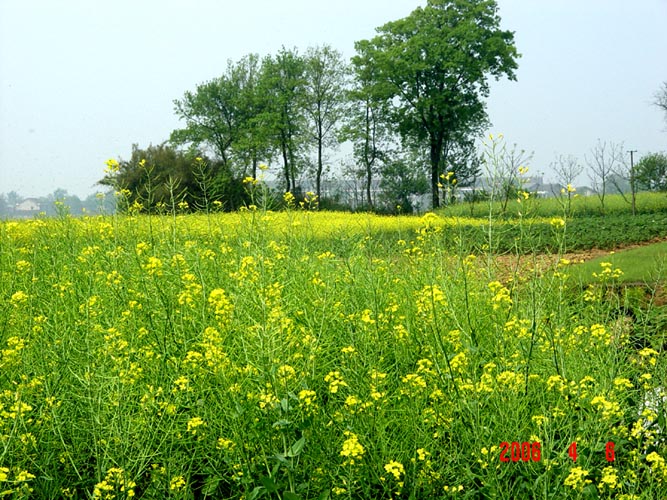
left=303, top=45, right=348, bottom=197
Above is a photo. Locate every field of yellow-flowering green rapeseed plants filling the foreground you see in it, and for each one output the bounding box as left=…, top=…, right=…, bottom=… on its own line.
left=0, top=205, right=667, bottom=500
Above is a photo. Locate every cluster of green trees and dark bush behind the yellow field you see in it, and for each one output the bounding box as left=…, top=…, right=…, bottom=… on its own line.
left=101, top=0, right=518, bottom=210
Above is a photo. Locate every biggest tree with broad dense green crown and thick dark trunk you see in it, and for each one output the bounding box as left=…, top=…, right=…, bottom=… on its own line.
left=358, top=0, right=518, bottom=207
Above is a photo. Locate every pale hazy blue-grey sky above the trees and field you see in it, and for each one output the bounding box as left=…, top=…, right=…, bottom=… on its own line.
left=0, top=0, right=667, bottom=197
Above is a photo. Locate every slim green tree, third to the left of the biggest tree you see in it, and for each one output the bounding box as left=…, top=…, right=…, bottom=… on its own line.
left=262, top=47, right=305, bottom=192
